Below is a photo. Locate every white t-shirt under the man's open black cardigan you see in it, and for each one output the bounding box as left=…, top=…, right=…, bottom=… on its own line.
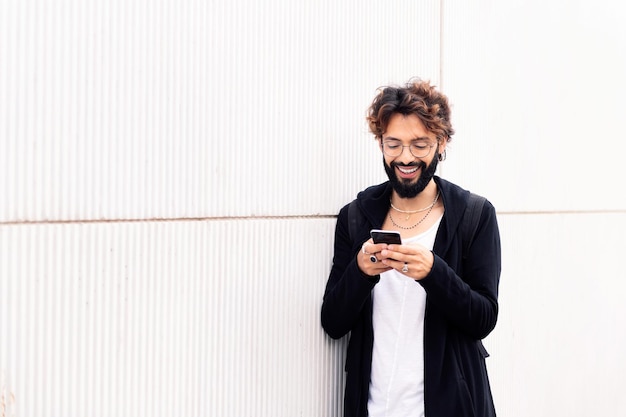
left=367, top=217, right=441, bottom=417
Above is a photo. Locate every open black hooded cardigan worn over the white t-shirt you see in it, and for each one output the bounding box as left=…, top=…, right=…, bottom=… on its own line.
left=321, top=177, right=500, bottom=417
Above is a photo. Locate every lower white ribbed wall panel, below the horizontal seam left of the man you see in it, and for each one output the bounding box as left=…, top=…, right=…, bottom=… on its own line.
left=0, top=219, right=343, bottom=417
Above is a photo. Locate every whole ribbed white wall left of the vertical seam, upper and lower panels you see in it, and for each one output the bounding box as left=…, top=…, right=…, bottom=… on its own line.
left=0, top=0, right=440, bottom=417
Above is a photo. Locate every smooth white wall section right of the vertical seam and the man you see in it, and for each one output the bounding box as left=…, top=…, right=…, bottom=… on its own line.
left=442, top=0, right=626, bottom=417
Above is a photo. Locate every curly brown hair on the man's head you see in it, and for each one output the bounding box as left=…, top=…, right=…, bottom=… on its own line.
left=366, top=80, right=454, bottom=142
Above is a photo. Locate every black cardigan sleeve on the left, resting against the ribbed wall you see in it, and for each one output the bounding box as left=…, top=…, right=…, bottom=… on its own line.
left=321, top=206, right=380, bottom=339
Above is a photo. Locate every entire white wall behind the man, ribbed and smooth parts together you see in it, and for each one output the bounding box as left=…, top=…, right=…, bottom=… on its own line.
left=0, top=0, right=626, bottom=417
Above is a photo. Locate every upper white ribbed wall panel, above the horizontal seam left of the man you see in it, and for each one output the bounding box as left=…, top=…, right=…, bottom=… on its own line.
left=0, top=0, right=439, bottom=221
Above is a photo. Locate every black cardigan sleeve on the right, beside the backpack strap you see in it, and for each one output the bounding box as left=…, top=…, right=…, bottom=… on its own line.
left=419, top=202, right=501, bottom=339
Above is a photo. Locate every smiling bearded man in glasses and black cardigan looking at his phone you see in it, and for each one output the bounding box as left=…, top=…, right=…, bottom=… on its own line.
left=321, top=81, right=500, bottom=417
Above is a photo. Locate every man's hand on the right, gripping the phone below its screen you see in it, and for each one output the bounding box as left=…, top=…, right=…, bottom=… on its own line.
left=380, top=240, right=435, bottom=281
